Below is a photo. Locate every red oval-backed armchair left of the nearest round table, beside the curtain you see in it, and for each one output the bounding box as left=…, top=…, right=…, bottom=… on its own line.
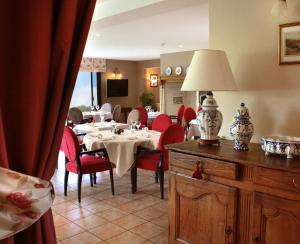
left=61, top=126, right=114, bottom=202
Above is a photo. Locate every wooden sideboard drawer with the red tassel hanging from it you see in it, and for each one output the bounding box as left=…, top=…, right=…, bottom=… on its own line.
left=170, top=151, right=238, bottom=180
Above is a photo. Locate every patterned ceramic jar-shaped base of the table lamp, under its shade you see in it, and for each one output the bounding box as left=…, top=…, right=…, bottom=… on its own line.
left=197, top=92, right=223, bottom=140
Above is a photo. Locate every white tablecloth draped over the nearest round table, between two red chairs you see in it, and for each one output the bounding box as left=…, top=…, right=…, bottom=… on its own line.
left=83, top=130, right=161, bottom=176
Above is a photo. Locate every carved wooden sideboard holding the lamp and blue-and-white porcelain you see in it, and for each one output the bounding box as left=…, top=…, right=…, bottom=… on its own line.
left=168, top=140, right=300, bottom=244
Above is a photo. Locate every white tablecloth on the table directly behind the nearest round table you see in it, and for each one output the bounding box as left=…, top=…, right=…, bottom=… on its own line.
left=73, top=122, right=129, bottom=134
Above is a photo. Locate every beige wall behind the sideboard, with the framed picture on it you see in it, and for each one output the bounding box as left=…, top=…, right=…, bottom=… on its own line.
left=209, top=0, right=300, bottom=142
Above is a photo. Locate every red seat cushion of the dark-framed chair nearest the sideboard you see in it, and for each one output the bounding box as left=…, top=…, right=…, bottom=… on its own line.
left=136, top=152, right=169, bottom=171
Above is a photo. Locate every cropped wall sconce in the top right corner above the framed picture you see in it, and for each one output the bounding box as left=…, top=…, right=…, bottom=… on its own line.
left=271, top=0, right=300, bottom=16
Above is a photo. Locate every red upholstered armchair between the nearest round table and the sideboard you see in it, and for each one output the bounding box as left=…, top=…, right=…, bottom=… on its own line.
left=131, top=124, right=184, bottom=199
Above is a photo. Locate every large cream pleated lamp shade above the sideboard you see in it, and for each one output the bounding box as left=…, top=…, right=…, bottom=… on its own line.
left=181, top=49, right=237, bottom=91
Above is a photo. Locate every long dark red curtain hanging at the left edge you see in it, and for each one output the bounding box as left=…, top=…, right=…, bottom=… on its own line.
left=0, top=0, right=96, bottom=243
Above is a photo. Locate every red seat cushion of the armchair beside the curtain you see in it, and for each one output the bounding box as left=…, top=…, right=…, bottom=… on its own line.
left=66, top=156, right=111, bottom=174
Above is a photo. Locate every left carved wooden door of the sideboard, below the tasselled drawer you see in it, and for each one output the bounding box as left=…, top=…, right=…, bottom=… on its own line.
left=169, top=174, right=237, bottom=244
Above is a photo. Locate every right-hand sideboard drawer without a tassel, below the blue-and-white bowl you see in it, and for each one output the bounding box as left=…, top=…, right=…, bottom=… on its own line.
left=253, top=167, right=300, bottom=192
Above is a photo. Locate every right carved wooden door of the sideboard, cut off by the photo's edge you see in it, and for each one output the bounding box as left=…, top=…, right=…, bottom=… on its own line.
left=251, top=193, right=300, bottom=244
